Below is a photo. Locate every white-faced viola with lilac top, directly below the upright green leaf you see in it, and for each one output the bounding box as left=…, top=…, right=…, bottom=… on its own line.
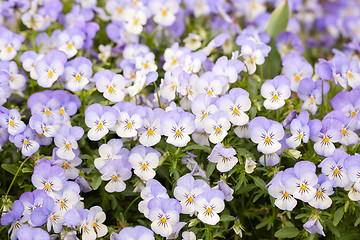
left=261, top=75, right=291, bottom=110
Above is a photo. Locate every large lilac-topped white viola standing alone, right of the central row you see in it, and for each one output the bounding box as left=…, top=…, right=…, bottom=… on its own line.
left=249, top=117, right=284, bottom=154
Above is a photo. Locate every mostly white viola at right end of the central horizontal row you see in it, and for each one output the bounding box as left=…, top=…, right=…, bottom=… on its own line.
left=204, top=111, right=230, bottom=144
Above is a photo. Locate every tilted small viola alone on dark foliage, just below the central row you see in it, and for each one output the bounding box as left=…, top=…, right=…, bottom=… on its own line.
left=208, top=143, right=238, bottom=172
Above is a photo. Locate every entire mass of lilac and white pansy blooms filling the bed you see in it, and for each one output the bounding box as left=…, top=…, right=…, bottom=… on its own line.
left=0, top=0, right=360, bottom=239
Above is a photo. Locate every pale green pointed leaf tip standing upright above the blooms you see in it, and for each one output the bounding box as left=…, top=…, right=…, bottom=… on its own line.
left=266, top=0, right=290, bottom=39
